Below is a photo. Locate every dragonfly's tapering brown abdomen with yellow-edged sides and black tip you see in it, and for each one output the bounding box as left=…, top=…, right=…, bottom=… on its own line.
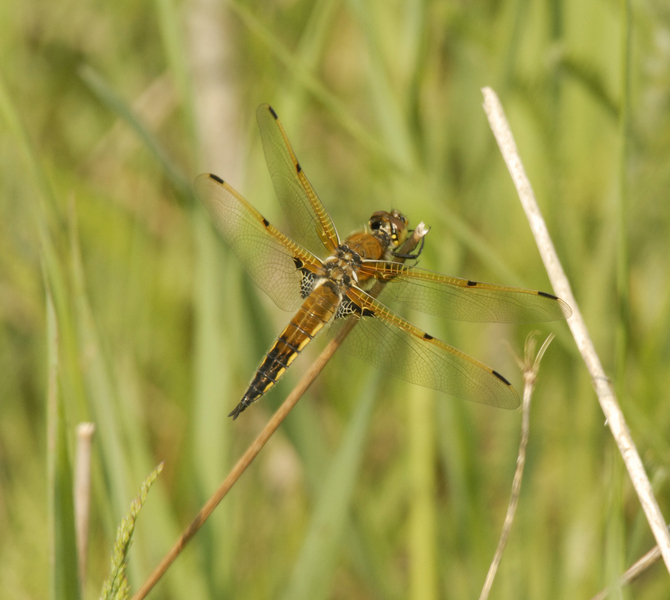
left=228, top=282, right=341, bottom=420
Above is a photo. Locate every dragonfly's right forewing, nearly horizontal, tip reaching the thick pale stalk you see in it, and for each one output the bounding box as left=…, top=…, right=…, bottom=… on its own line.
left=361, top=261, right=572, bottom=323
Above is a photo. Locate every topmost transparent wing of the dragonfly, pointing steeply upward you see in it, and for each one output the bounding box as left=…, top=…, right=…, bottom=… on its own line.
left=256, top=104, right=340, bottom=257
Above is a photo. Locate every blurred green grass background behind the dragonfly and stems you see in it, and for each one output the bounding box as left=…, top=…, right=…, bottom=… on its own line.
left=0, top=0, right=670, bottom=600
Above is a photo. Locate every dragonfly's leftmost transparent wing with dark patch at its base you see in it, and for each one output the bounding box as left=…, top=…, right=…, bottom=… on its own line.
left=195, top=173, right=320, bottom=311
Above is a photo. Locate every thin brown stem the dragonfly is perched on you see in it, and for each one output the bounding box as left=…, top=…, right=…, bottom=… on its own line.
left=132, top=223, right=428, bottom=600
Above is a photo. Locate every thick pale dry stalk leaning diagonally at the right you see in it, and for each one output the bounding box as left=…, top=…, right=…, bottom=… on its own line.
left=482, top=87, right=670, bottom=571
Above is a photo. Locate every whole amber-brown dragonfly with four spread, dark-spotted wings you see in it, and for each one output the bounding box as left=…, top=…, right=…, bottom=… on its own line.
left=195, top=104, right=572, bottom=420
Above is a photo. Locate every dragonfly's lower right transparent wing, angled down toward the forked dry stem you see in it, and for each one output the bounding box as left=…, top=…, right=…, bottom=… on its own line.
left=342, top=288, right=519, bottom=408
